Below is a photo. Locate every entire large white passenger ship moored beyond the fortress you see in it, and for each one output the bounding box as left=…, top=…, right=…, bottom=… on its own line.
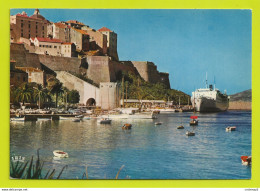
left=191, top=77, right=229, bottom=112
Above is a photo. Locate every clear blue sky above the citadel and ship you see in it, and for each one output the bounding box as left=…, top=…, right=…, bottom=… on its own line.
left=10, top=9, right=252, bottom=95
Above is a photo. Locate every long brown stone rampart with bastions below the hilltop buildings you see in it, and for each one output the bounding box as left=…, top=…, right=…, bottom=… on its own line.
left=10, top=43, right=170, bottom=88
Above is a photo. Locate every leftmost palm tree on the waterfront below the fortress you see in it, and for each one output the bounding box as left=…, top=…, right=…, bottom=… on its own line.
left=16, top=83, right=32, bottom=105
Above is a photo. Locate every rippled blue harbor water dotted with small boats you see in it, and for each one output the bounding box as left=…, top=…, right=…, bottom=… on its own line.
left=10, top=111, right=251, bottom=179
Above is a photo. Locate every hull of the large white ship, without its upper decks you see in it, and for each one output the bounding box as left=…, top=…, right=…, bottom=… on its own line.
left=195, top=97, right=229, bottom=112
